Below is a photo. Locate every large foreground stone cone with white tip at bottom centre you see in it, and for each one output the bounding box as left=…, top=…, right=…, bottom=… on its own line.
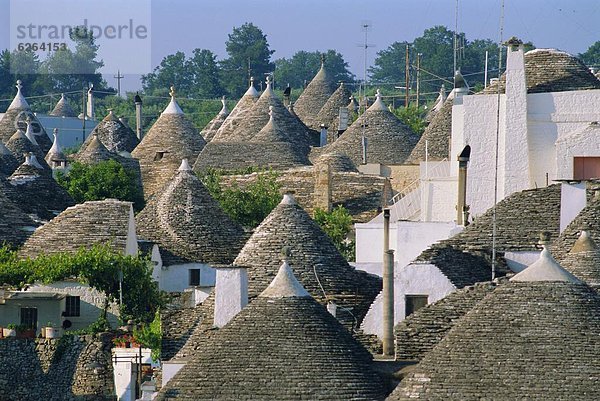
left=156, top=263, right=384, bottom=401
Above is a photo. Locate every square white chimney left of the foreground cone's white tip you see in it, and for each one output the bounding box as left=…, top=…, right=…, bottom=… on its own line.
left=214, top=266, right=248, bottom=327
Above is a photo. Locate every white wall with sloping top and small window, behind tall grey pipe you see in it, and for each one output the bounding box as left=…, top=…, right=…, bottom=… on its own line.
left=361, top=263, right=456, bottom=338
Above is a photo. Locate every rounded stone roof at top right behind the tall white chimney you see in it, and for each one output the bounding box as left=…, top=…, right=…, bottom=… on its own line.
left=482, top=49, right=600, bottom=94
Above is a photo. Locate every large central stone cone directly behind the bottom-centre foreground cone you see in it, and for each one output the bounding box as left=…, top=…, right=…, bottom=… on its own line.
left=234, top=194, right=381, bottom=324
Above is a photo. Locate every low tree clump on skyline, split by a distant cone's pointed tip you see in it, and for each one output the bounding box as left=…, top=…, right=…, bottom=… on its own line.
left=273, top=50, right=354, bottom=88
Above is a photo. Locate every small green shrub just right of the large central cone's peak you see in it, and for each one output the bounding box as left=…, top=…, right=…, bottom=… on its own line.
left=314, top=205, right=356, bottom=261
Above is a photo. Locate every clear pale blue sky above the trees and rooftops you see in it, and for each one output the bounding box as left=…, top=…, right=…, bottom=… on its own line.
left=0, top=0, right=600, bottom=90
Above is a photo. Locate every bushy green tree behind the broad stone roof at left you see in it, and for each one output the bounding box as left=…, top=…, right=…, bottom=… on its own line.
left=57, top=160, right=144, bottom=210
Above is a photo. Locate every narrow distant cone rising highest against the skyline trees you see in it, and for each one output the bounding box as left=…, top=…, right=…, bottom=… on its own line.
left=294, top=59, right=338, bottom=130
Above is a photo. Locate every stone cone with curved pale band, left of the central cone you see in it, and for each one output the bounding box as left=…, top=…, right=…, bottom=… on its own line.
left=136, top=160, right=246, bottom=266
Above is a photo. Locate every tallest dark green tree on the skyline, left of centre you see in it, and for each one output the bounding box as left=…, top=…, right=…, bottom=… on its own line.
left=220, top=22, right=275, bottom=98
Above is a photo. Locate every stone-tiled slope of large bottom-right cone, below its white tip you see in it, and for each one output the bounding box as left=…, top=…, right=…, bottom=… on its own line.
left=388, top=281, right=600, bottom=400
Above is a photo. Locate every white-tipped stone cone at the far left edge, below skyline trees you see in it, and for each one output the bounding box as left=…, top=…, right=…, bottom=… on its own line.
left=0, top=80, right=52, bottom=152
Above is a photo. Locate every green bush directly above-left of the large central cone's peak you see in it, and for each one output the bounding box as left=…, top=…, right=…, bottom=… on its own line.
left=200, top=169, right=281, bottom=228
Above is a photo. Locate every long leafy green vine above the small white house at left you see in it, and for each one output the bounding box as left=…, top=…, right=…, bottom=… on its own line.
left=0, top=245, right=164, bottom=327
